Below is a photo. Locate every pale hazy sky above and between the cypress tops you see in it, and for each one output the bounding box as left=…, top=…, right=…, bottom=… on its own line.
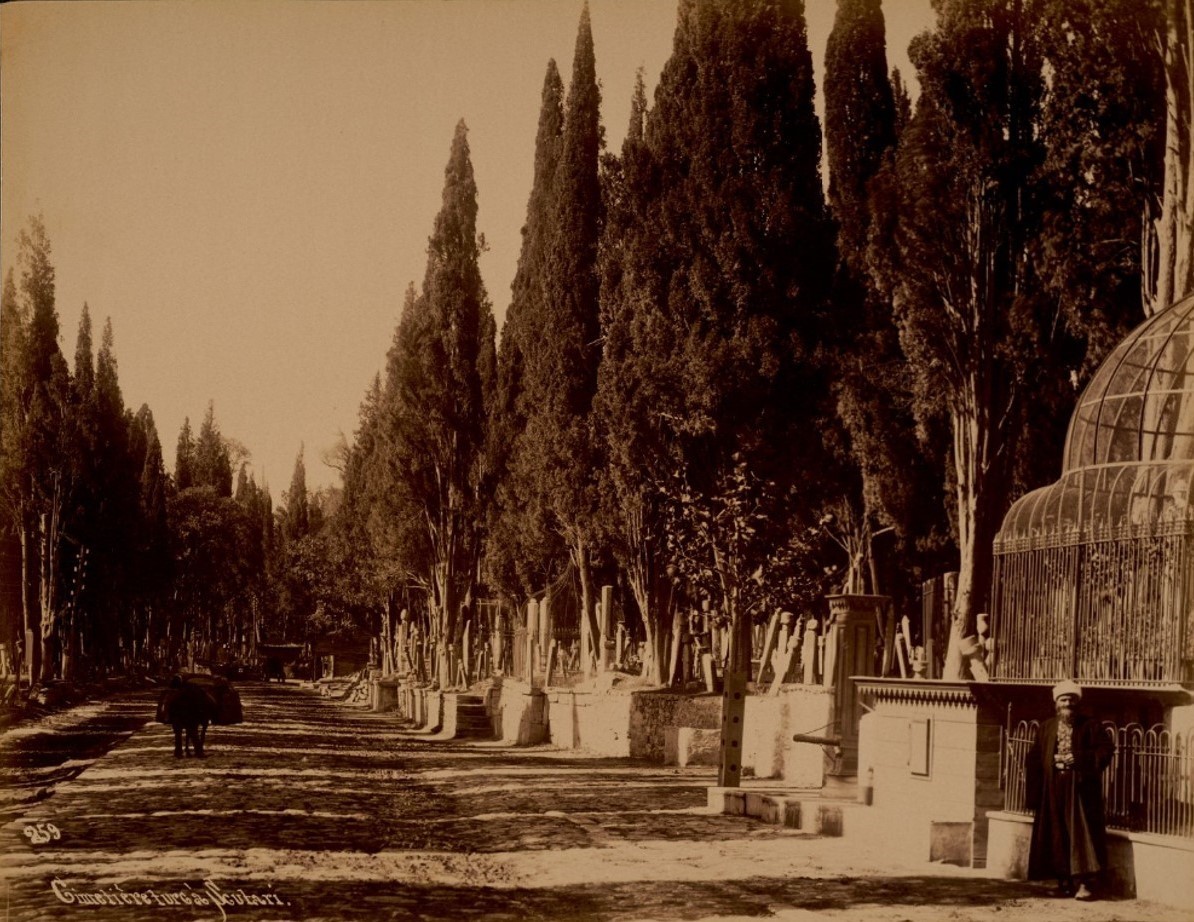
left=0, top=0, right=931, bottom=503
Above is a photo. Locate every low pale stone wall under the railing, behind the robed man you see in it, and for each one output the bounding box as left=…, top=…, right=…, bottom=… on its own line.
left=987, top=811, right=1194, bottom=912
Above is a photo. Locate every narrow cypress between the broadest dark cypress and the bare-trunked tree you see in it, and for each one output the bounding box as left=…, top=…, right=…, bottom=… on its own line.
left=824, top=0, right=944, bottom=594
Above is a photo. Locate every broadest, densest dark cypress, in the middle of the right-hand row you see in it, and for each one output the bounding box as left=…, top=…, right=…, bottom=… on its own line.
left=601, top=0, right=831, bottom=668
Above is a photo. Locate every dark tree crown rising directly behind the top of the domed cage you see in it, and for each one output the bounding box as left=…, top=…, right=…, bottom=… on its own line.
left=1034, top=0, right=1165, bottom=355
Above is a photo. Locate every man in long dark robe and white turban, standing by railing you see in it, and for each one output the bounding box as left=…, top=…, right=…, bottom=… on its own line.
left=1024, top=681, right=1115, bottom=899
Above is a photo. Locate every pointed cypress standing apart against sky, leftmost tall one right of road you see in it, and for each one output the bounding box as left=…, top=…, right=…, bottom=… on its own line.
left=375, top=121, right=493, bottom=687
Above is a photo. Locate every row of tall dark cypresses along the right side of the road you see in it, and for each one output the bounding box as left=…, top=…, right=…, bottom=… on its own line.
left=322, top=0, right=1189, bottom=678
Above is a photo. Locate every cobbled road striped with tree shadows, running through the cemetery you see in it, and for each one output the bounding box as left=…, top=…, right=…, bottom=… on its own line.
left=0, top=684, right=1187, bottom=922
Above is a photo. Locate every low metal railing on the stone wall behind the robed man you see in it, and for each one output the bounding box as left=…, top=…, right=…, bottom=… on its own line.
left=1003, top=720, right=1194, bottom=838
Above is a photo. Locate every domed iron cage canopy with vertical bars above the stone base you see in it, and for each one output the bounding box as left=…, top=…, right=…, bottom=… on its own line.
left=992, top=296, right=1194, bottom=683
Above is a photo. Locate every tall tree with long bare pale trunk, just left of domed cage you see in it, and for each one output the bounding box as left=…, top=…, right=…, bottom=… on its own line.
left=888, top=0, right=1042, bottom=677
